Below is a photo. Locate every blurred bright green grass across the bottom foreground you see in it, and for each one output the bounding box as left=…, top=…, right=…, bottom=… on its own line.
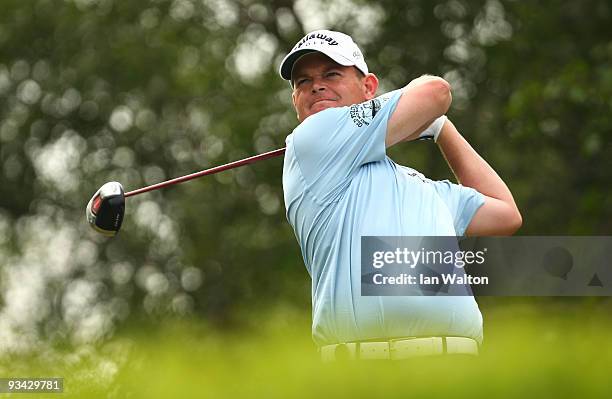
left=0, top=298, right=612, bottom=398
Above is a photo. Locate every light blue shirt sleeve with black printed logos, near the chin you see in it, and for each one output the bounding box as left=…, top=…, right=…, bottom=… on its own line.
left=292, top=90, right=401, bottom=203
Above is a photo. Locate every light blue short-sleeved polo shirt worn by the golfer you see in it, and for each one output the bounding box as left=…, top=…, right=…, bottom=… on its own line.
left=283, top=90, right=484, bottom=345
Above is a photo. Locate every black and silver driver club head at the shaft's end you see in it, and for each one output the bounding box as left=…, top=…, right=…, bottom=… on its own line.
left=85, top=181, right=125, bottom=237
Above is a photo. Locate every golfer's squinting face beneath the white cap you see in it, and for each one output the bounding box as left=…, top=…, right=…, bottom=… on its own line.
left=291, top=52, right=378, bottom=122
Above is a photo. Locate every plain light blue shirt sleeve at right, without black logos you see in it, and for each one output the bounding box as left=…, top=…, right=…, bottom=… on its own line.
left=432, top=180, right=485, bottom=236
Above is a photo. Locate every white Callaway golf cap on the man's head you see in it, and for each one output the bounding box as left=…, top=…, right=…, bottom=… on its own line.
left=279, top=30, right=368, bottom=80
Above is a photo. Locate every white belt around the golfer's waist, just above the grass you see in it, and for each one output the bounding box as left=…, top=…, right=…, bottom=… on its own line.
left=320, top=337, right=478, bottom=362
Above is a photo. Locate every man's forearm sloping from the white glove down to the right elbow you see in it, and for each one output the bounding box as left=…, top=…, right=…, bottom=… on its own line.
left=437, top=120, right=516, bottom=208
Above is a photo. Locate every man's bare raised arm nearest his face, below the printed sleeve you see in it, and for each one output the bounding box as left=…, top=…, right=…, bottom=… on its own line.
left=385, top=75, right=452, bottom=148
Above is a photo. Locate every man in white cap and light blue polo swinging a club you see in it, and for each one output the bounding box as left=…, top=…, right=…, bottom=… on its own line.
left=280, top=30, right=522, bottom=359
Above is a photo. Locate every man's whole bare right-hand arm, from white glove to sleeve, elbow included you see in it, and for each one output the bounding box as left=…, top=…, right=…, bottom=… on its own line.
left=437, top=120, right=523, bottom=236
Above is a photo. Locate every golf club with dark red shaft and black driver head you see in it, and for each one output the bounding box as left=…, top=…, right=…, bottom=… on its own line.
left=85, top=148, right=285, bottom=237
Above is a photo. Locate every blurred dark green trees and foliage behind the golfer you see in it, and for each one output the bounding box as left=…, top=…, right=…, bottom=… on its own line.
left=0, top=0, right=612, bottom=396
